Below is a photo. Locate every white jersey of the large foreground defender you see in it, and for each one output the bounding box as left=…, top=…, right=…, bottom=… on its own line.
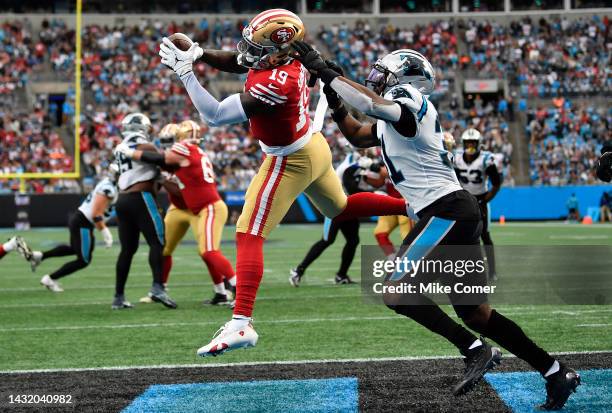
left=376, top=84, right=461, bottom=213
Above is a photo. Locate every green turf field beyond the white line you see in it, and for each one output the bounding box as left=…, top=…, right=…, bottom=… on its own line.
left=0, top=223, right=612, bottom=370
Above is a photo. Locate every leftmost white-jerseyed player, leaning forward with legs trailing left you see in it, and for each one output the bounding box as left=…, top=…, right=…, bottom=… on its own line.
left=29, top=169, right=119, bottom=293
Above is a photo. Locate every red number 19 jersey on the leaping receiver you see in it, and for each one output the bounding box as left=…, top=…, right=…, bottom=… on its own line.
left=244, top=60, right=310, bottom=146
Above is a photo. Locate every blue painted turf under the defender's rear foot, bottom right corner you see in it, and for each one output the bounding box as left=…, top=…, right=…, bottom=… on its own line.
left=485, top=369, right=612, bottom=413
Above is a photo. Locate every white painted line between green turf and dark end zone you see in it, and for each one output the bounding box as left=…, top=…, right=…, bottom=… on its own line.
left=0, top=349, right=612, bottom=375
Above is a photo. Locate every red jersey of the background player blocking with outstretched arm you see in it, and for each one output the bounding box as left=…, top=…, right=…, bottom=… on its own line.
left=171, top=143, right=221, bottom=214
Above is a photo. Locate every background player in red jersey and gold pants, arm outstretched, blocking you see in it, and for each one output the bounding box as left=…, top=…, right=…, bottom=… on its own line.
left=116, top=120, right=236, bottom=305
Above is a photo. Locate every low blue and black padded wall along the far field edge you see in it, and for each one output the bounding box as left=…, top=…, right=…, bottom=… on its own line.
left=0, top=185, right=612, bottom=227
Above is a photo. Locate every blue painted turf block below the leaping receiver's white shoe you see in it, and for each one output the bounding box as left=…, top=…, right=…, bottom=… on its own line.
left=123, top=377, right=359, bottom=413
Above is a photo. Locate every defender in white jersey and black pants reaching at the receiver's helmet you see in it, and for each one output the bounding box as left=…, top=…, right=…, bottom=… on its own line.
left=292, top=42, right=580, bottom=410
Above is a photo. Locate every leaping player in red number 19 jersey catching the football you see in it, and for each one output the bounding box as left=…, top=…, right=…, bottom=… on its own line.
left=159, top=9, right=406, bottom=356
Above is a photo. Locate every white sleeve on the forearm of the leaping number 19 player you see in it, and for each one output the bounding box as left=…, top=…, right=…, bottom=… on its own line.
left=181, top=73, right=248, bottom=126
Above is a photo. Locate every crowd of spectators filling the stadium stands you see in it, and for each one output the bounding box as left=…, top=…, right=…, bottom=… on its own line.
left=0, top=16, right=612, bottom=191
